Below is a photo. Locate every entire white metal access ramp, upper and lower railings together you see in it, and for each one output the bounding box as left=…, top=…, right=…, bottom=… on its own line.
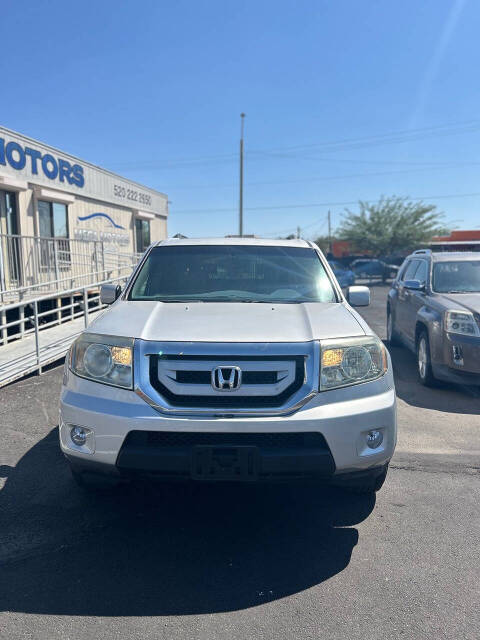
left=0, top=234, right=140, bottom=386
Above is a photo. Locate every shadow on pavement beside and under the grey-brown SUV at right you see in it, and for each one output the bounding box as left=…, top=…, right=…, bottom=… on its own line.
left=386, top=344, right=480, bottom=415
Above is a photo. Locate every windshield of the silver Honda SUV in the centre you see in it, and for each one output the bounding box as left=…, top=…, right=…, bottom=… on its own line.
left=129, top=245, right=337, bottom=303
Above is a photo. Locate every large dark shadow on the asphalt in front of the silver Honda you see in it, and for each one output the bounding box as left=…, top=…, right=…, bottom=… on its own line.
left=0, top=429, right=375, bottom=616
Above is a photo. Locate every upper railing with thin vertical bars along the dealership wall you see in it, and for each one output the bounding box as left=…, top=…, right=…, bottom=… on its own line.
left=0, top=234, right=139, bottom=307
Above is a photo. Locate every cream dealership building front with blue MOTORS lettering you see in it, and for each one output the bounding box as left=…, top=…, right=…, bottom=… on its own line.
left=0, top=127, right=168, bottom=298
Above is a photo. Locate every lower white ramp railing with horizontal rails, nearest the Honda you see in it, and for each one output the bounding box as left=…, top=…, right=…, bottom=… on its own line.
left=0, top=273, right=130, bottom=387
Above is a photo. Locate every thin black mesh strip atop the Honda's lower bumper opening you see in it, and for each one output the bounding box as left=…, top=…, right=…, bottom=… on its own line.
left=124, top=431, right=328, bottom=450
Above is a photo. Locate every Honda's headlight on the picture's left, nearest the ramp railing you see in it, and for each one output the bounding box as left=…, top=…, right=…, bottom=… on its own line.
left=70, top=333, right=133, bottom=389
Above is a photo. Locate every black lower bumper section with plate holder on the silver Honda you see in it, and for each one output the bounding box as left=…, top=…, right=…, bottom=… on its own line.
left=68, top=431, right=335, bottom=481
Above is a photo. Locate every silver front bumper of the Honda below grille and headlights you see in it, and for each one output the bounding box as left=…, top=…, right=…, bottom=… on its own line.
left=60, top=364, right=396, bottom=478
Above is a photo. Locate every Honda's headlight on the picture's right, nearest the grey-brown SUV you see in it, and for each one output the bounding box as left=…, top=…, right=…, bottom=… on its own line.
left=320, top=336, right=387, bottom=391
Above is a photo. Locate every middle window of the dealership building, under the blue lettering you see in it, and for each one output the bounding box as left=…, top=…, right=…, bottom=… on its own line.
left=38, top=200, right=71, bottom=274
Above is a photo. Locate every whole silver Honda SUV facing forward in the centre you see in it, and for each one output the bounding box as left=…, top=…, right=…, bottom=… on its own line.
left=60, top=238, right=396, bottom=492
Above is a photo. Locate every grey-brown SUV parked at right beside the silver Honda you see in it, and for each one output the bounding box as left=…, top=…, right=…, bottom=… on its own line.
left=387, top=249, right=480, bottom=385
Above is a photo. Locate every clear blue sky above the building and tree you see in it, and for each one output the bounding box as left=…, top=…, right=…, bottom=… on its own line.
left=0, top=0, right=480, bottom=237
